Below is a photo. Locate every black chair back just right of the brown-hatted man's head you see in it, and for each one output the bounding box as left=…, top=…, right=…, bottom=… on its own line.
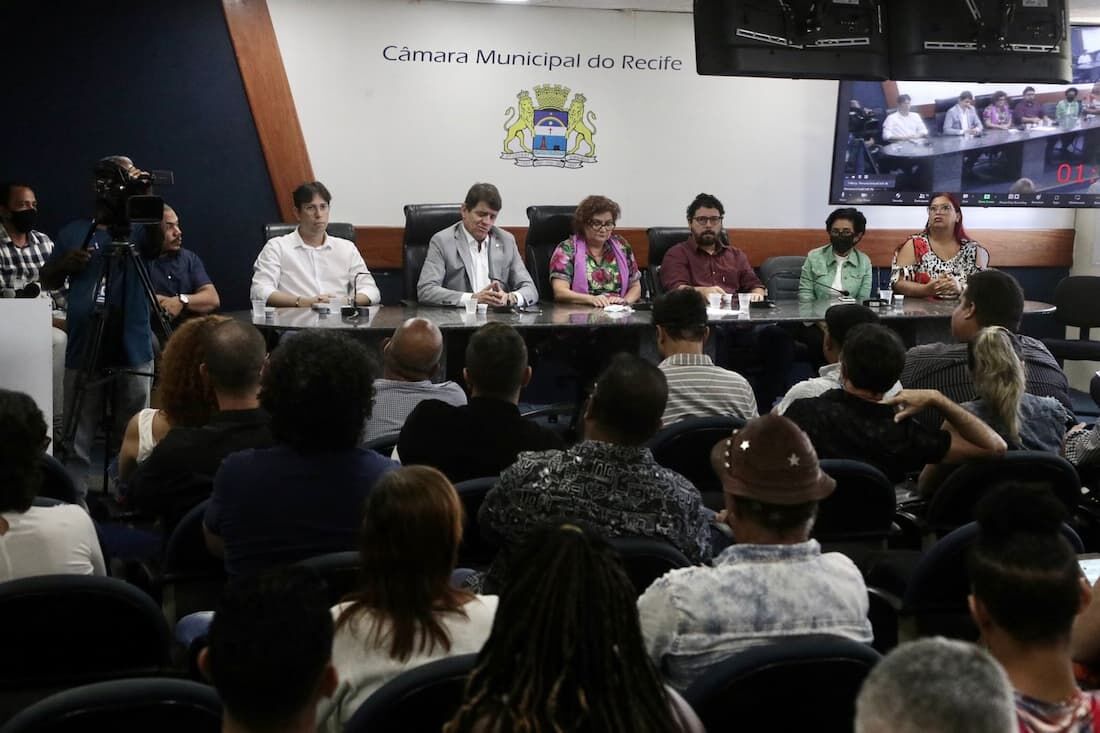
left=813, top=458, right=897, bottom=556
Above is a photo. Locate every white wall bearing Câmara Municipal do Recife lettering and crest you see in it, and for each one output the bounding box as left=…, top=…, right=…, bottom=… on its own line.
left=268, top=0, right=1074, bottom=228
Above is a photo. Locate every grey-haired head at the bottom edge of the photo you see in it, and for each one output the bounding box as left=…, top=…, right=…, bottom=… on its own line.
left=856, top=636, right=1020, bottom=733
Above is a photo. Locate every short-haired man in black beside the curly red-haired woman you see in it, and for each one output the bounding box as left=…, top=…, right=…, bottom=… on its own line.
left=127, top=320, right=273, bottom=534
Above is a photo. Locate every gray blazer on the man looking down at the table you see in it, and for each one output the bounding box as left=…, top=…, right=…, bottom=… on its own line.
left=416, top=221, right=539, bottom=306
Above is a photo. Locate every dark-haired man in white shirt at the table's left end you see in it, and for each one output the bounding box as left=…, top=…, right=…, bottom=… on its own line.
left=252, top=180, right=382, bottom=308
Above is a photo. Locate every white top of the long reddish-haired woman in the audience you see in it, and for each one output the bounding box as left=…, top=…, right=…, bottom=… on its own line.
left=317, top=595, right=497, bottom=733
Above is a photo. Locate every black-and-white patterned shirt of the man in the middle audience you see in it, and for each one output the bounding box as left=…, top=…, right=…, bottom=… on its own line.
left=477, top=440, right=711, bottom=588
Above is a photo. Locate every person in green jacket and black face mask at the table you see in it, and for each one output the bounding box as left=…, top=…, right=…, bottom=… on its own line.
left=799, top=208, right=871, bottom=303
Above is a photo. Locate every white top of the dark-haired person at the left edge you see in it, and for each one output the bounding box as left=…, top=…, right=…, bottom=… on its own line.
left=0, top=504, right=107, bottom=581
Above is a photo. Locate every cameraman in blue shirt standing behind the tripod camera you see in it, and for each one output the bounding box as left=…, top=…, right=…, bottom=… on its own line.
left=42, top=150, right=153, bottom=501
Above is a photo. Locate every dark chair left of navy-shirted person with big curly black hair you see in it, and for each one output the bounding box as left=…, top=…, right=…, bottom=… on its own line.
left=157, top=500, right=226, bottom=621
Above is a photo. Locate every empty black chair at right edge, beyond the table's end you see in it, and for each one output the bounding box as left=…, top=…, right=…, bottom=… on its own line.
left=1043, top=275, right=1100, bottom=416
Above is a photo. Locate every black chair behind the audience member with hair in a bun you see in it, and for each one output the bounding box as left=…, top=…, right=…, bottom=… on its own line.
left=900, top=522, right=1085, bottom=642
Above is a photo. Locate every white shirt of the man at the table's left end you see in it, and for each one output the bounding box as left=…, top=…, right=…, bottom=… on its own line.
left=252, top=229, right=382, bottom=304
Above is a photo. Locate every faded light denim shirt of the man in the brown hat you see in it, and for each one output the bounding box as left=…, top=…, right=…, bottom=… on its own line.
left=638, top=539, right=872, bottom=690
